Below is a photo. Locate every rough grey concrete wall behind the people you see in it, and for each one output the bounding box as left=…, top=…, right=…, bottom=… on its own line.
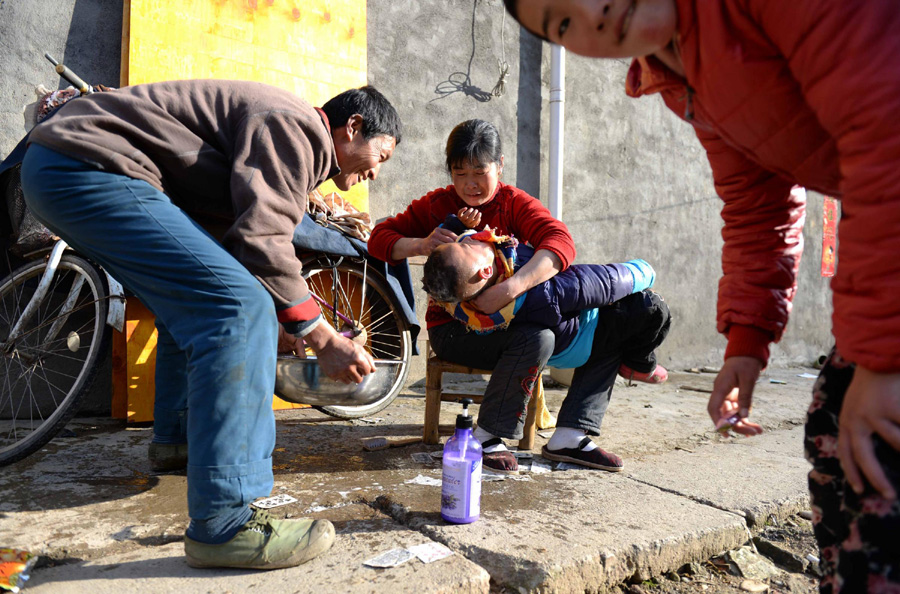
left=0, top=0, right=831, bottom=376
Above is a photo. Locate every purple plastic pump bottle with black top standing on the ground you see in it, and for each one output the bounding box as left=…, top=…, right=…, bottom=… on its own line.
left=441, top=398, right=481, bottom=524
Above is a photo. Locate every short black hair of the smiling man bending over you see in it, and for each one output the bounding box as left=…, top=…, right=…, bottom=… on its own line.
left=322, top=85, right=403, bottom=144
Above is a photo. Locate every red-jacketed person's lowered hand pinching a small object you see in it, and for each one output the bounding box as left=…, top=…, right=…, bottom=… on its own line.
left=706, top=357, right=763, bottom=435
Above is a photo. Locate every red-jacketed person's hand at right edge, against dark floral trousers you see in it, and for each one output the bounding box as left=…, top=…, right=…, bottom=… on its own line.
left=838, top=365, right=900, bottom=500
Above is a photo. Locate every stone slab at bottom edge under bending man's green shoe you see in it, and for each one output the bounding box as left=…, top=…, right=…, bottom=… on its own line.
left=27, top=504, right=490, bottom=594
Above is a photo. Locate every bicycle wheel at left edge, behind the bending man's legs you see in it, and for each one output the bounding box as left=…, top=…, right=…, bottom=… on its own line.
left=0, top=254, right=109, bottom=466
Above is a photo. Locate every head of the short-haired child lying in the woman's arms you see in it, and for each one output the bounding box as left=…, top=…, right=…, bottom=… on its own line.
left=422, top=237, right=496, bottom=302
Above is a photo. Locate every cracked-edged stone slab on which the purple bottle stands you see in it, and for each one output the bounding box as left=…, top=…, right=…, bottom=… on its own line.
left=378, top=470, right=748, bottom=592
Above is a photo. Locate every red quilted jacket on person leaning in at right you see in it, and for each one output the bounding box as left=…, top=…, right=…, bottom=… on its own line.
left=627, top=0, right=900, bottom=372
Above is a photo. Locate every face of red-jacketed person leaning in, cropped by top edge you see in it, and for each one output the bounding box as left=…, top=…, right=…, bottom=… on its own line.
left=503, top=0, right=678, bottom=58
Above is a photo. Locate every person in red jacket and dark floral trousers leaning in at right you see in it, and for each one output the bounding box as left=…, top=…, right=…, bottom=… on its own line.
left=504, top=0, right=900, bottom=592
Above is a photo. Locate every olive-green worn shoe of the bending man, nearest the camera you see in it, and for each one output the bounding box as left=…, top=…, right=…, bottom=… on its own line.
left=184, top=509, right=334, bottom=569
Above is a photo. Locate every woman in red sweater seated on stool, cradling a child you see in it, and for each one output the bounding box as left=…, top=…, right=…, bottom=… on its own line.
left=369, top=120, right=575, bottom=472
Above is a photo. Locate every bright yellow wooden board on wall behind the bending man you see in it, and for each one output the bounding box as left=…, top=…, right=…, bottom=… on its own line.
left=122, top=0, right=369, bottom=211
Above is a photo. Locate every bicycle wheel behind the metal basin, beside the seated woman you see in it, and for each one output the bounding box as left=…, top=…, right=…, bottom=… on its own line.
left=303, top=258, right=412, bottom=419
